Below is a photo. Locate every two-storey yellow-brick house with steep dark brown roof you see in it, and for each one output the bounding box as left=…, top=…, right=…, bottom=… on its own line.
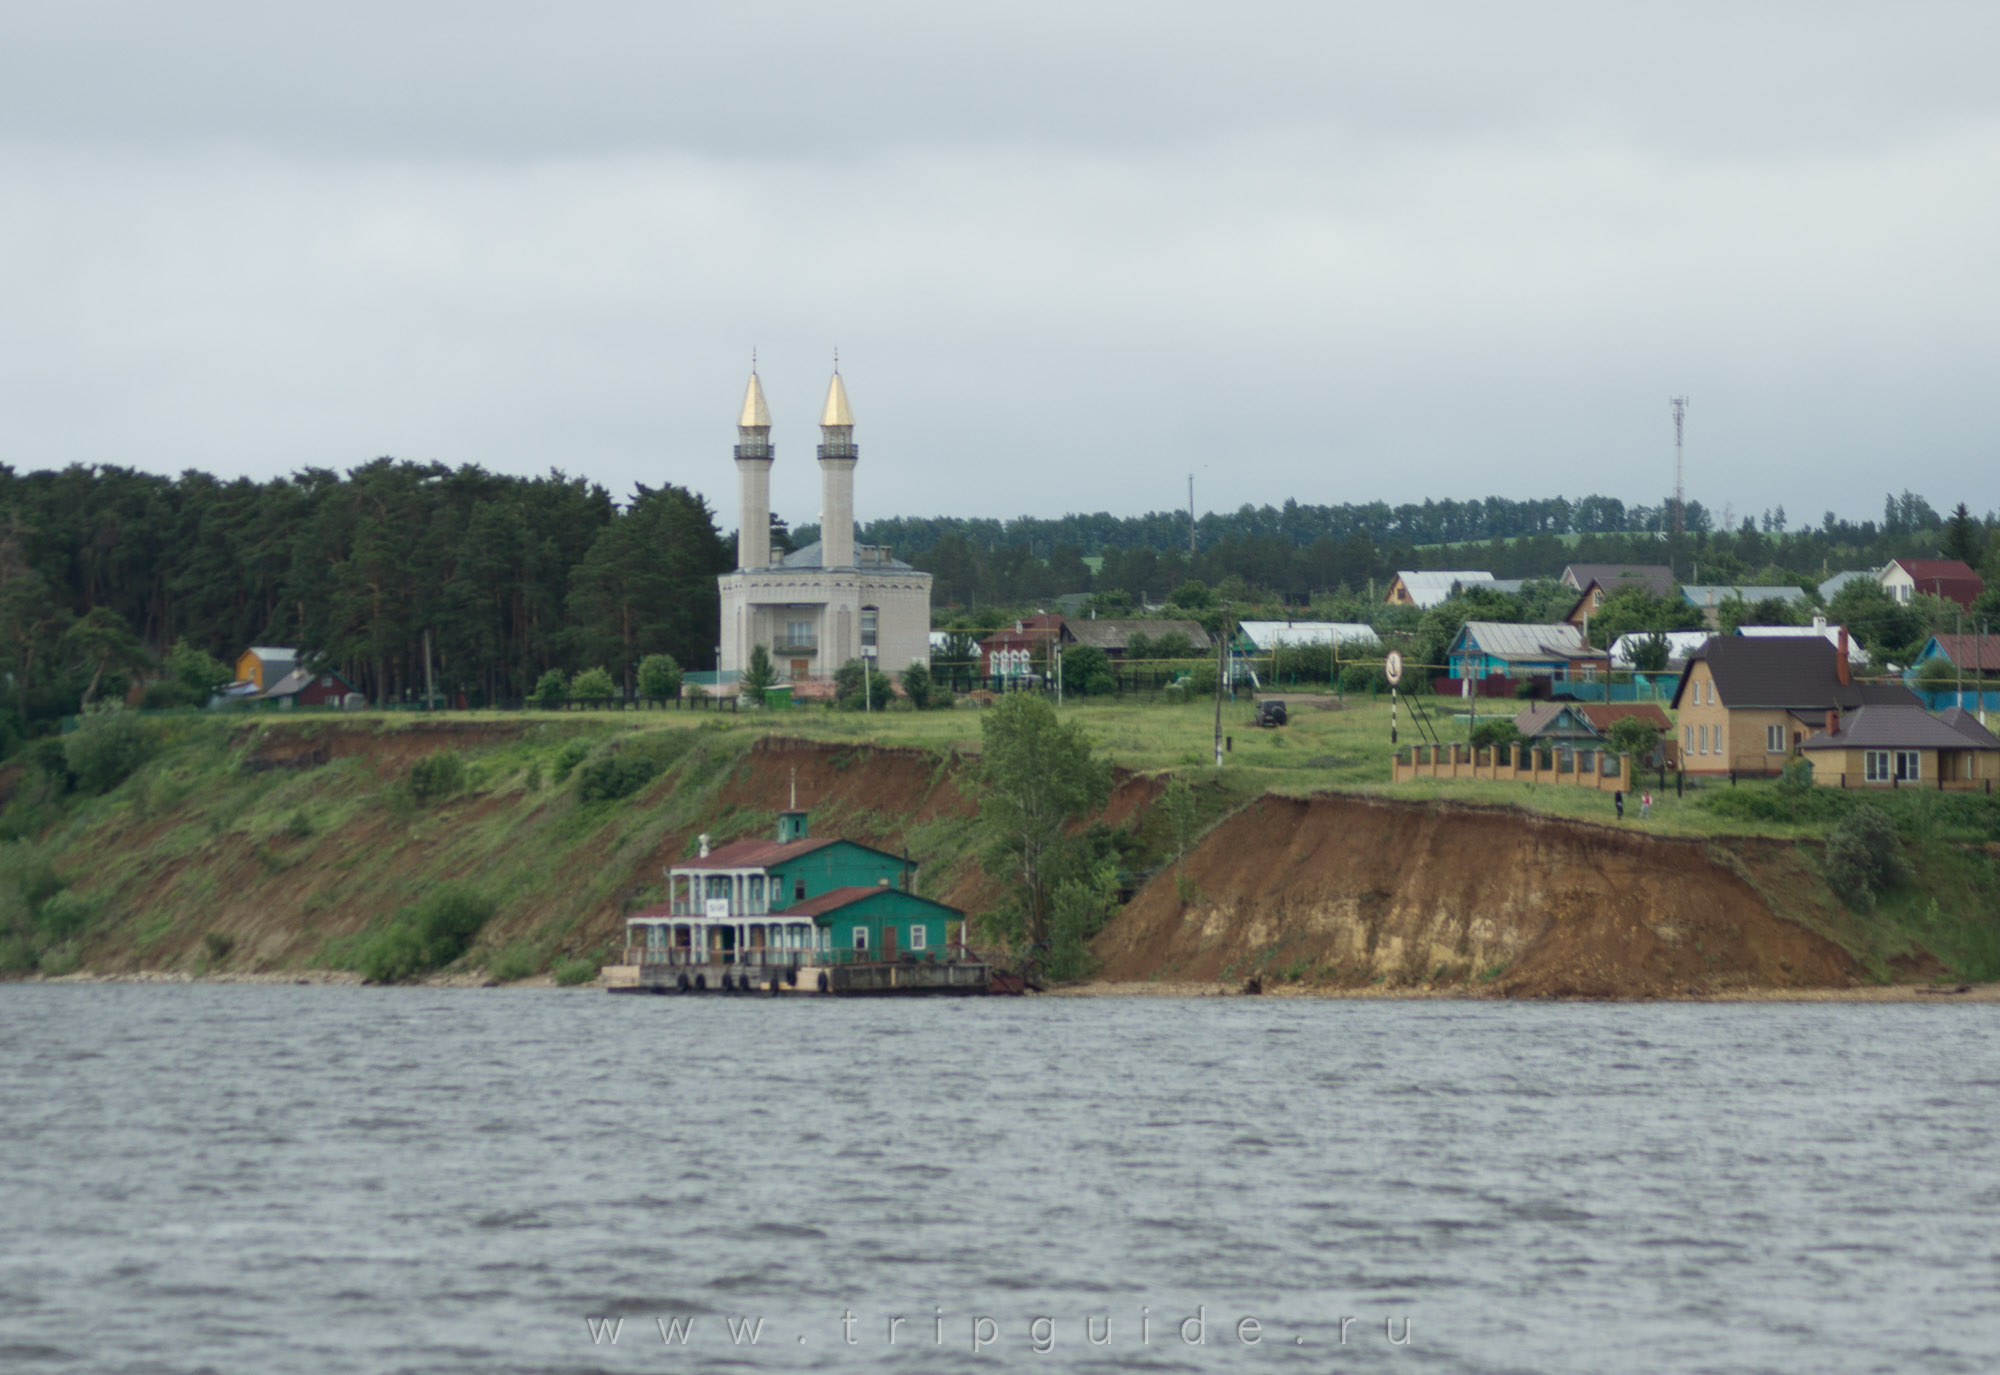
left=1672, top=636, right=1916, bottom=773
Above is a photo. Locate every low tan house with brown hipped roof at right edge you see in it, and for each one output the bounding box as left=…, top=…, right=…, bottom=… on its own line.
left=1800, top=705, right=2000, bottom=793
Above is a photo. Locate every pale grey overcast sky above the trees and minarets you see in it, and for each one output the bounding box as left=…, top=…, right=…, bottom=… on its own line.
left=0, top=0, right=2000, bottom=528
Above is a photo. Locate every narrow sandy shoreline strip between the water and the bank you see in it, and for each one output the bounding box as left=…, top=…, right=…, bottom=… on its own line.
left=19, top=969, right=2000, bottom=1003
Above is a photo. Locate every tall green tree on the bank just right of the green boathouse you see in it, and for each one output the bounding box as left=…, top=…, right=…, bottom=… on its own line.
left=974, top=691, right=1112, bottom=957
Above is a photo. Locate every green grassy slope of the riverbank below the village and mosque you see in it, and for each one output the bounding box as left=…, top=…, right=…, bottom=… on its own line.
left=3, top=697, right=2000, bottom=977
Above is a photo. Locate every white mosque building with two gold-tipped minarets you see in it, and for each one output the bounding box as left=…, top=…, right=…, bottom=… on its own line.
left=716, top=368, right=930, bottom=680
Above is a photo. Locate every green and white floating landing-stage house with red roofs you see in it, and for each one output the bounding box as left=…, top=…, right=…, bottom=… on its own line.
left=626, top=811, right=964, bottom=965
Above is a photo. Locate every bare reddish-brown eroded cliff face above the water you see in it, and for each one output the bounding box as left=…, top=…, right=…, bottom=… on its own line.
left=1096, top=795, right=1852, bottom=997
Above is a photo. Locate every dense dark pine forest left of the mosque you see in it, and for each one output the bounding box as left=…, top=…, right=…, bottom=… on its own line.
left=0, top=458, right=736, bottom=729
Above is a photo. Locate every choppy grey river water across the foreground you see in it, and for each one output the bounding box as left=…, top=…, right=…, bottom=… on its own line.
left=0, top=985, right=2000, bottom=1375
